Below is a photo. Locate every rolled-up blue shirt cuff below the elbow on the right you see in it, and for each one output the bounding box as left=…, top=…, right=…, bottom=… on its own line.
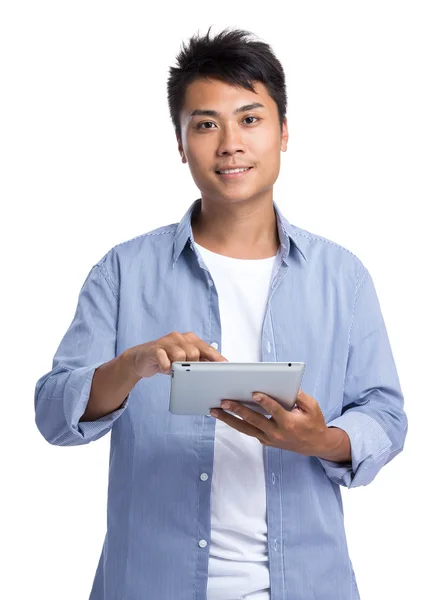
left=318, top=409, right=392, bottom=488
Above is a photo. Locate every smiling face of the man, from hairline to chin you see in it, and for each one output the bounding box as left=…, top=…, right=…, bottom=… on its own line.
left=177, top=78, right=288, bottom=209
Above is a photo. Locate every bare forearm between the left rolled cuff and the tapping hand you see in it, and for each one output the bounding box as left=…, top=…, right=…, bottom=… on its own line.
left=80, top=349, right=142, bottom=421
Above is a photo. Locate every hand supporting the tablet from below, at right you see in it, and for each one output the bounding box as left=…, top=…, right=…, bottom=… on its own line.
left=211, top=390, right=328, bottom=456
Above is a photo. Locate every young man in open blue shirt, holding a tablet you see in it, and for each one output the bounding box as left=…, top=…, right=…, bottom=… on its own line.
left=35, top=25, right=408, bottom=600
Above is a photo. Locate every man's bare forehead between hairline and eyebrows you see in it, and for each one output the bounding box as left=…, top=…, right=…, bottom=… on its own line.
left=182, top=78, right=275, bottom=119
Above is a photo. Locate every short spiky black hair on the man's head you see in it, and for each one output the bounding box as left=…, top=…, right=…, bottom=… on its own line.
left=167, top=25, right=287, bottom=141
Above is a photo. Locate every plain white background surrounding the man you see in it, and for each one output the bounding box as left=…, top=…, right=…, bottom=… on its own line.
left=0, top=0, right=443, bottom=600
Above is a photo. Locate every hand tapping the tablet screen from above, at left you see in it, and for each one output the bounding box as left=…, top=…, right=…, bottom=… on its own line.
left=126, top=331, right=228, bottom=377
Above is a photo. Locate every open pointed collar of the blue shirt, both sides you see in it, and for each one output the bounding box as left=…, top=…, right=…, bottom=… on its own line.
left=172, top=198, right=308, bottom=267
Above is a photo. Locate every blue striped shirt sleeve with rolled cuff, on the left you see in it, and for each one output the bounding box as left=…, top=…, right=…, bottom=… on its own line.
left=34, top=259, right=131, bottom=446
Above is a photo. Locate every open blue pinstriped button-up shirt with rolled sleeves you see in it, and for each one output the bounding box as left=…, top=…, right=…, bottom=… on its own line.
left=35, top=199, right=408, bottom=600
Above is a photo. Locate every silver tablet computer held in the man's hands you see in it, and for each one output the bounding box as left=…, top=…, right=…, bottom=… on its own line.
left=169, top=361, right=306, bottom=416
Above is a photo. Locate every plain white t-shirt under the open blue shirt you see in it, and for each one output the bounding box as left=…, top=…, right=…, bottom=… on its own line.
left=195, top=244, right=275, bottom=600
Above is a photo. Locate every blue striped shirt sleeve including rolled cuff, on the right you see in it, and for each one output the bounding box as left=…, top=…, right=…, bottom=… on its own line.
left=319, top=267, right=408, bottom=488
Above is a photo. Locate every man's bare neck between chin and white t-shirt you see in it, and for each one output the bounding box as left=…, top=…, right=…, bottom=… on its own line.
left=192, top=199, right=280, bottom=259
